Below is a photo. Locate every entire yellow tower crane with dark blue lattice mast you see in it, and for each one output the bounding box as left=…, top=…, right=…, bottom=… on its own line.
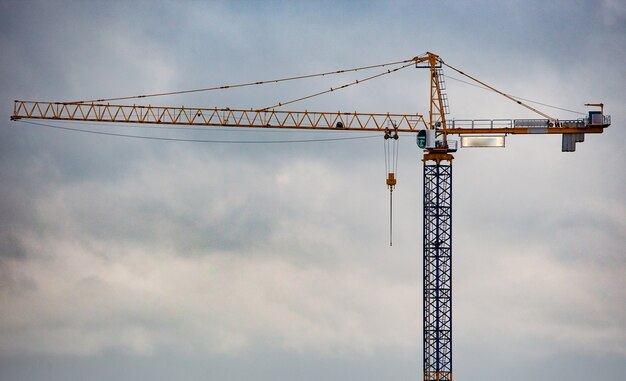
left=11, top=52, right=611, bottom=381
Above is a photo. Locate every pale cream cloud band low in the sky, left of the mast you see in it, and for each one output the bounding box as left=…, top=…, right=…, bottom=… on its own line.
left=1, top=236, right=418, bottom=355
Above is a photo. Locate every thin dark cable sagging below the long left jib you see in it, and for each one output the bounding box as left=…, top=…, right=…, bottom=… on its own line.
left=18, top=120, right=380, bottom=144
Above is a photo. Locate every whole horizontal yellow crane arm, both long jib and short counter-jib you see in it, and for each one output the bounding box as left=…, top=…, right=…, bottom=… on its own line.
left=11, top=100, right=610, bottom=135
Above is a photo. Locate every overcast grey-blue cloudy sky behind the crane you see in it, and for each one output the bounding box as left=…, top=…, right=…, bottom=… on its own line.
left=0, top=0, right=626, bottom=381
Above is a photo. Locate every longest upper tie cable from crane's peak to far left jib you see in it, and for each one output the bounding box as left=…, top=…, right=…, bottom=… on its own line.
left=65, top=59, right=413, bottom=104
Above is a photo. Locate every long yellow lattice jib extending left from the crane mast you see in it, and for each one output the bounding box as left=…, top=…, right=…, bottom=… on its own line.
left=11, top=101, right=428, bottom=132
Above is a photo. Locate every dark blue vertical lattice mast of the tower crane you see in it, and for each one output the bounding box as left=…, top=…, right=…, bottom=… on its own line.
left=423, top=154, right=452, bottom=381
